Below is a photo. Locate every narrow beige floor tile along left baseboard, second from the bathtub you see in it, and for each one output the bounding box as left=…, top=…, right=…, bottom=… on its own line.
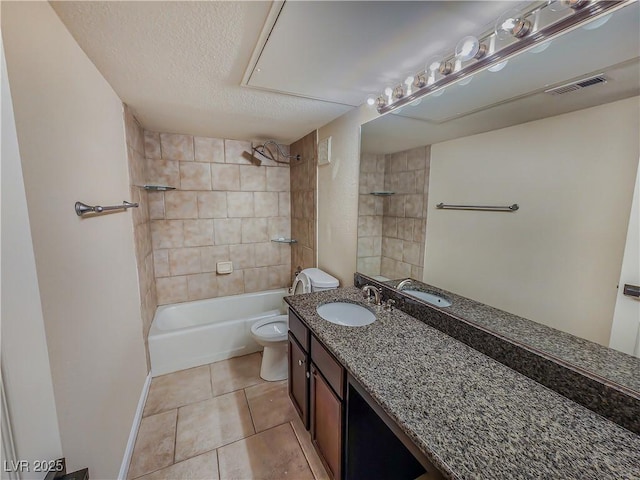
left=128, top=410, right=177, bottom=478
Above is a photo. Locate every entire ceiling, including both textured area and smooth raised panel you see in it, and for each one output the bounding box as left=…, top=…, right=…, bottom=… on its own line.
left=51, top=0, right=521, bottom=143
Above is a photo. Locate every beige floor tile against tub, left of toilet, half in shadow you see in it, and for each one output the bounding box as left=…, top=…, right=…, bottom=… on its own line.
left=210, top=353, right=264, bottom=397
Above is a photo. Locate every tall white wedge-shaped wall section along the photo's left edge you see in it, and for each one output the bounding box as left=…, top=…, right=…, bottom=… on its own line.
left=0, top=36, right=62, bottom=479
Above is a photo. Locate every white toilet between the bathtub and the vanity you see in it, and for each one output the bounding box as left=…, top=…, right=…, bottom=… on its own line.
left=251, top=268, right=338, bottom=382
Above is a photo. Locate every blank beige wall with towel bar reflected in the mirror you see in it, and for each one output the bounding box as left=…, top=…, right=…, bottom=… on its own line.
left=424, top=97, right=640, bottom=345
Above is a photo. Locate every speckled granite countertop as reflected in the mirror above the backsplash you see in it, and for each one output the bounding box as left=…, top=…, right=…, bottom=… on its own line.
left=385, top=280, right=640, bottom=396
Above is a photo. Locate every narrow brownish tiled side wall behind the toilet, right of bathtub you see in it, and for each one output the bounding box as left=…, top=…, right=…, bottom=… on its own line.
left=291, top=131, right=318, bottom=274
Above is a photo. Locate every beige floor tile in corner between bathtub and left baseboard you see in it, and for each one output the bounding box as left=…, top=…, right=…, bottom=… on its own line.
left=143, top=365, right=212, bottom=416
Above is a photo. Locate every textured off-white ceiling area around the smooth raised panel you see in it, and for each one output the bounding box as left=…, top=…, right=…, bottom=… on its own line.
left=51, top=2, right=350, bottom=143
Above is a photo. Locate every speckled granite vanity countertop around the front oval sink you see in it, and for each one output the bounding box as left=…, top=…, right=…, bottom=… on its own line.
left=286, top=287, right=640, bottom=480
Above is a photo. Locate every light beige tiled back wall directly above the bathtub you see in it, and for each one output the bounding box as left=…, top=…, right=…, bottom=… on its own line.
left=144, top=131, right=291, bottom=305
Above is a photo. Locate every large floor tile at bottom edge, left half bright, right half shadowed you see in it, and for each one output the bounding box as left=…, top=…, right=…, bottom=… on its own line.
left=218, top=424, right=313, bottom=480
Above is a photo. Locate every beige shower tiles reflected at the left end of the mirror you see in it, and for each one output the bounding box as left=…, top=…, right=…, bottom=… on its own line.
left=357, top=146, right=430, bottom=279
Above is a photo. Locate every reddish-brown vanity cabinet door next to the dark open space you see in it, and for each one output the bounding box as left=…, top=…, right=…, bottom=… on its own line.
left=311, top=365, right=342, bottom=480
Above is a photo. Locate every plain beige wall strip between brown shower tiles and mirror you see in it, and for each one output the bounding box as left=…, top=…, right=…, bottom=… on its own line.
left=317, top=104, right=378, bottom=286
